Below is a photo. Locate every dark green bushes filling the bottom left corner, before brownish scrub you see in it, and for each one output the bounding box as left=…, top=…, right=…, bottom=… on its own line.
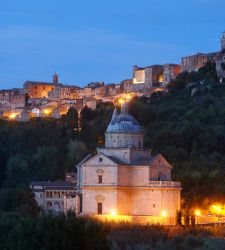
left=0, top=213, right=109, bottom=250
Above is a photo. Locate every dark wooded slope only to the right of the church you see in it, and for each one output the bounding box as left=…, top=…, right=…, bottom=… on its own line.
left=130, top=73, right=225, bottom=206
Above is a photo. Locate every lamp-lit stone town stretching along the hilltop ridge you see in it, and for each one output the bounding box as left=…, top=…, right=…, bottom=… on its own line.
left=0, top=32, right=225, bottom=121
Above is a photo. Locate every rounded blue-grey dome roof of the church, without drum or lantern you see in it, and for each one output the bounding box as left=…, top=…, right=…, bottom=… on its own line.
left=106, top=113, right=143, bottom=133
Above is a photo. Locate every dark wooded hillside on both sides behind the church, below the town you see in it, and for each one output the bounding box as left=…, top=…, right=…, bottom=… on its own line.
left=0, top=63, right=225, bottom=209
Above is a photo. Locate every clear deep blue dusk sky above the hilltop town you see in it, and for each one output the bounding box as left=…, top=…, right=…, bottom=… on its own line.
left=0, top=0, right=225, bottom=88
